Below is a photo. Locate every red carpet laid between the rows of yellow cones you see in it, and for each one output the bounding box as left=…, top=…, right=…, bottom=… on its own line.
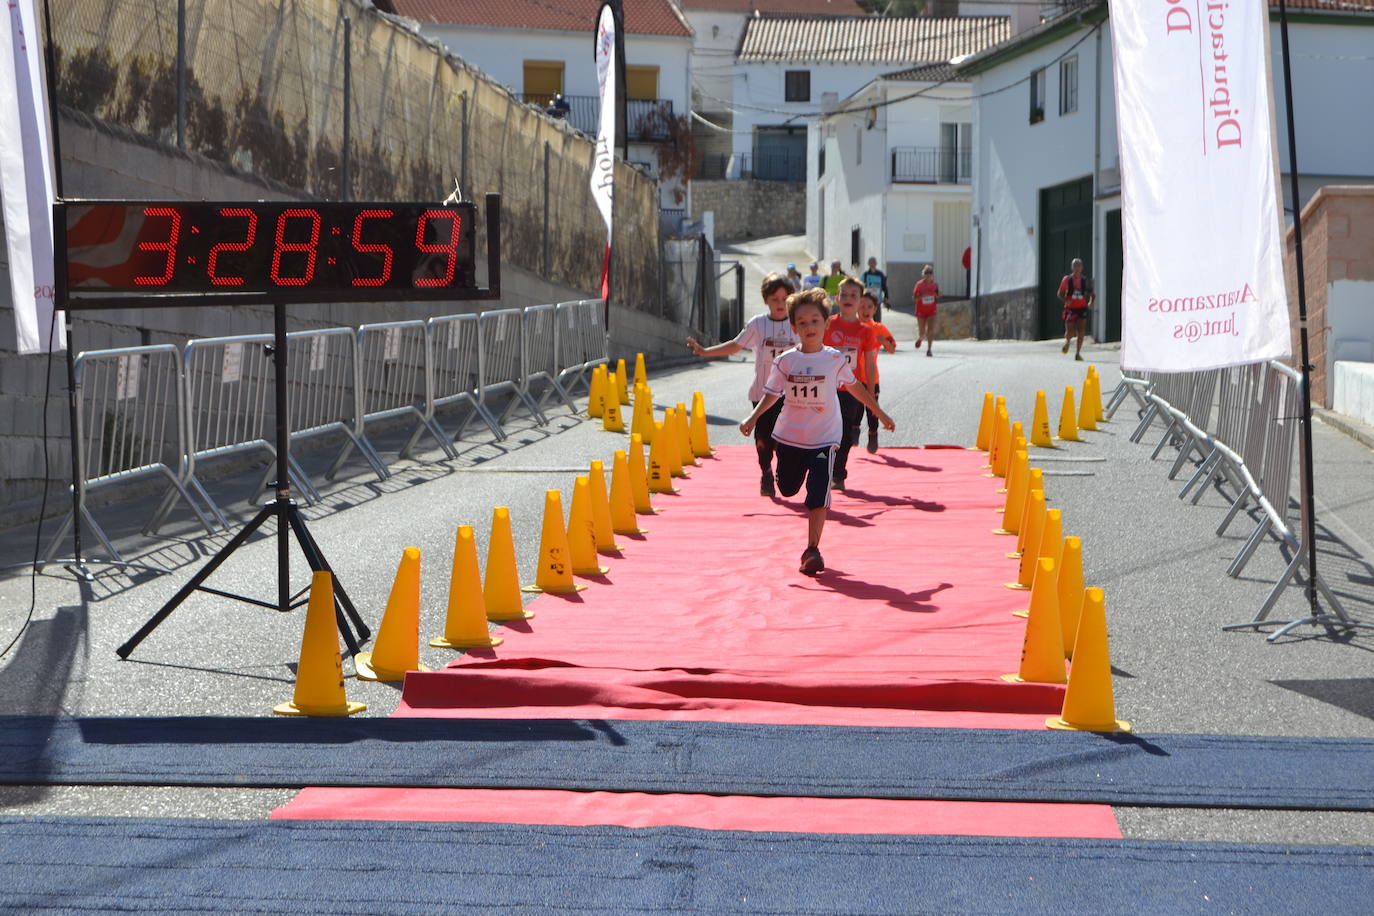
left=275, top=446, right=1120, bottom=838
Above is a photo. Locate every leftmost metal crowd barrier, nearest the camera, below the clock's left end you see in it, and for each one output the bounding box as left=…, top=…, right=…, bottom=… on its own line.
left=43, top=343, right=214, bottom=563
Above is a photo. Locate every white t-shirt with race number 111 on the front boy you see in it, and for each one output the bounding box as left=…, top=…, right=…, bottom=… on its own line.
left=764, top=346, right=855, bottom=449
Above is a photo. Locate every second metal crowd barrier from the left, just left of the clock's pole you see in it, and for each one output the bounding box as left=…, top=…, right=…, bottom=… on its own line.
left=181, top=334, right=320, bottom=521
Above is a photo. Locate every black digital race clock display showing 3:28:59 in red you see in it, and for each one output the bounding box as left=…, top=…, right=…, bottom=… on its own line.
left=55, top=195, right=500, bottom=309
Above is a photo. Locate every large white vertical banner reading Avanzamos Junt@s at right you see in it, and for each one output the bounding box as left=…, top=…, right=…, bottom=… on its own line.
left=1110, top=0, right=1290, bottom=372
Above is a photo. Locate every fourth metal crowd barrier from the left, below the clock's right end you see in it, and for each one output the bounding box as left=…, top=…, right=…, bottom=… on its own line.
left=357, top=321, right=458, bottom=466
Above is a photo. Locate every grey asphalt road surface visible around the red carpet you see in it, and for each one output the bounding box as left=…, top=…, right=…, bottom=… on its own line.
left=0, top=239, right=1374, bottom=843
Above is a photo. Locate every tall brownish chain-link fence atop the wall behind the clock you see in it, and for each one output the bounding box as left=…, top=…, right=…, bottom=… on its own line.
left=52, top=0, right=662, bottom=307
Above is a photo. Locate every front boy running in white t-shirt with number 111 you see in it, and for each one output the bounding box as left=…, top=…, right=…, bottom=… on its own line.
left=739, top=290, right=896, bottom=575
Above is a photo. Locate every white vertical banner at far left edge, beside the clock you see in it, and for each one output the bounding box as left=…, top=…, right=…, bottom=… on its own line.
left=0, top=0, right=63, bottom=353
